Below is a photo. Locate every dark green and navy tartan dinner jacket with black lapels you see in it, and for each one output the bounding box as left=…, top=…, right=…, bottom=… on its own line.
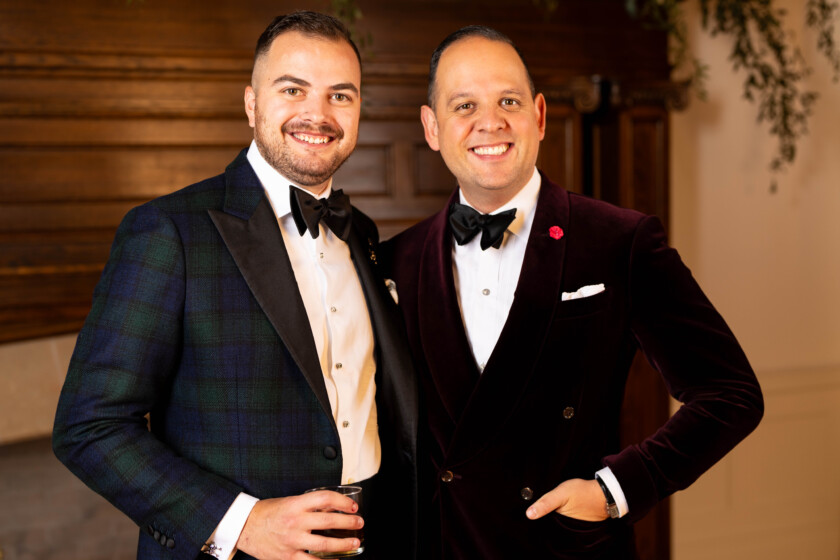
left=53, top=150, right=418, bottom=560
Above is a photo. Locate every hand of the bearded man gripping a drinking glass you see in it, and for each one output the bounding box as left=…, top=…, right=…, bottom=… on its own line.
left=236, top=490, right=364, bottom=560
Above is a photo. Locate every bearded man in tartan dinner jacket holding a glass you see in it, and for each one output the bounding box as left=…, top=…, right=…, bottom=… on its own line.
left=53, top=12, right=417, bottom=560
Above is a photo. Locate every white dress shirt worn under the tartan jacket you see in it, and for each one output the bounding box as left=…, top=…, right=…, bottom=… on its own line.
left=209, top=142, right=381, bottom=558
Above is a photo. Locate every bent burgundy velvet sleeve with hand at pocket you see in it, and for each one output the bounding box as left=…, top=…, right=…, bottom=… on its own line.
left=604, top=217, right=764, bottom=522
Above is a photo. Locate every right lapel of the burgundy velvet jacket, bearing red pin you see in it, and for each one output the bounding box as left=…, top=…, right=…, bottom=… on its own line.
left=450, top=179, right=569, bottom=462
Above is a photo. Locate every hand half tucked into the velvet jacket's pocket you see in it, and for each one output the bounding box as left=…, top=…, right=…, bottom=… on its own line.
left=525, top=478, right=609, bottom=521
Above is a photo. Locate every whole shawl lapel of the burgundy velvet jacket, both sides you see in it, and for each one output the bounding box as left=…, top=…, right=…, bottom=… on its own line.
left=418, top=177, right=569, bottom=466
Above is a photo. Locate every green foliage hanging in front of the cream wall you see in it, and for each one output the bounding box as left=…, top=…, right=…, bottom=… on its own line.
left=625, top=0, right=840, bottom=172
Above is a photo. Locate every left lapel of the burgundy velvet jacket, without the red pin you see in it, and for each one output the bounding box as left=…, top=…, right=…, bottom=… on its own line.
left=418, top=212, right=478, bottom=422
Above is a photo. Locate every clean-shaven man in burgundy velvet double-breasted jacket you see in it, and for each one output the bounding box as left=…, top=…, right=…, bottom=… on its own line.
left=383, top=27, right=763, bottom=560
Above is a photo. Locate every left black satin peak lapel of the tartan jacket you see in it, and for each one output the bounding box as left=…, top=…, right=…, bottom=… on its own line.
left=208, top=196, right=333, bottom=418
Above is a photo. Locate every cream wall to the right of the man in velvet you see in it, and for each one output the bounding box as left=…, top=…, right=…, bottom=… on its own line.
left=671, top=0, right=840, bottom=560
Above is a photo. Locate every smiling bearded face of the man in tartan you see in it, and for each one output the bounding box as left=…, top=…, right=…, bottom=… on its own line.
left=245, top=31, right=361, bottom=194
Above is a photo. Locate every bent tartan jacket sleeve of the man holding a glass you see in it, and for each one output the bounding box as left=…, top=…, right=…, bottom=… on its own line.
left=53, top=205, right=241, bottom=560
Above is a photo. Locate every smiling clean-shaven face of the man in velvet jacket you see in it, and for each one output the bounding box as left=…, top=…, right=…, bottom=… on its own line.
left=421, top=37, right=545, bottom=212
